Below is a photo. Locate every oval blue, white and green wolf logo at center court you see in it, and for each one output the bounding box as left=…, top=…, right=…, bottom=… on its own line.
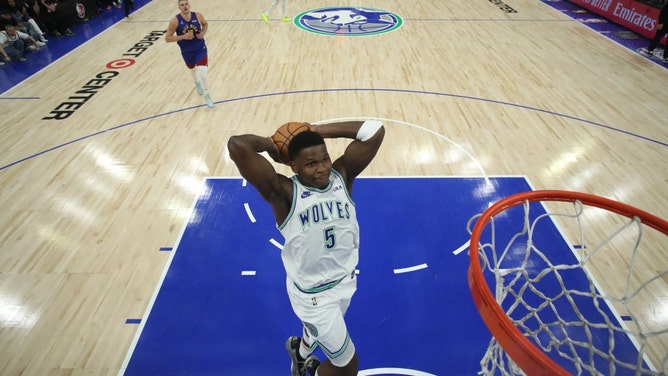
left=294, top=7, right=403, bottom=36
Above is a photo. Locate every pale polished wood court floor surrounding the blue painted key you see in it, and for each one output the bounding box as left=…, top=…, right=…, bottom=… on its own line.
left=0, top=0, right=668, bottom=375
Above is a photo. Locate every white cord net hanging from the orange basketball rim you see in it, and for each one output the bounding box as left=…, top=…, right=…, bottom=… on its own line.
left=468, top=201, right=668, bottom=375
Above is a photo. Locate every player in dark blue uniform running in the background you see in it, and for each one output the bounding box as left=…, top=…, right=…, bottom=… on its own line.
left=165, top=0, right=213, bottom=108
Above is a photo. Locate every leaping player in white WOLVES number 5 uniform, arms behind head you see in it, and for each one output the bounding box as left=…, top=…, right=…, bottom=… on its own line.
left=227, top=120, right=385, bottom=376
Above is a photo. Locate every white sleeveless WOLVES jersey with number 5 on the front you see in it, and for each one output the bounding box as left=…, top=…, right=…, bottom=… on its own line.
left=278, top=169, right=359, bottom=293
